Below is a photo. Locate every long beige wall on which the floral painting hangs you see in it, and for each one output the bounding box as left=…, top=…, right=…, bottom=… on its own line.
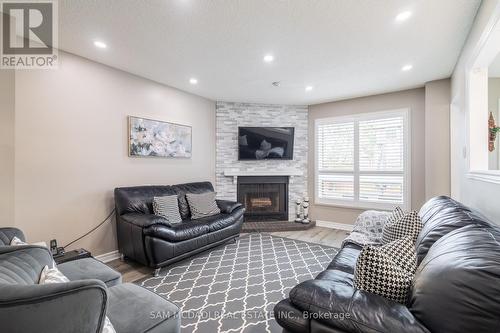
left=15, top=52, right=215, bottom=255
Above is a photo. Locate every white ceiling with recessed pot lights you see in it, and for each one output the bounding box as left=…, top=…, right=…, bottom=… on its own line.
left=59, top=0, right=480, bottom=104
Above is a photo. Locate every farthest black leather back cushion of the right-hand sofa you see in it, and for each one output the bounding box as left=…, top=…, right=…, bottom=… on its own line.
left=416, top=196, right=491, bottom=263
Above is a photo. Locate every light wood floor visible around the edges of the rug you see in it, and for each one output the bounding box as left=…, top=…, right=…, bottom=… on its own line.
left=108, top=227, right=349, bottom=282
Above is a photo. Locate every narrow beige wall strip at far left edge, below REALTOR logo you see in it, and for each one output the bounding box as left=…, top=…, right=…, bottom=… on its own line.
left=0, top=70, right=15, bottom=227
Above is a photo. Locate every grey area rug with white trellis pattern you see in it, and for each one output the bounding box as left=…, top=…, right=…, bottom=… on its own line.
left=137, top=233, right=338, bottom=333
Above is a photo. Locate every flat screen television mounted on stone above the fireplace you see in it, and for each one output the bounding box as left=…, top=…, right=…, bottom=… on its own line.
left=238, top=127, right=295, bottom=160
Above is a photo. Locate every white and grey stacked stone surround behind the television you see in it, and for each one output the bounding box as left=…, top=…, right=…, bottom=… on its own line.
left=215, top=102, right=308, bottom=220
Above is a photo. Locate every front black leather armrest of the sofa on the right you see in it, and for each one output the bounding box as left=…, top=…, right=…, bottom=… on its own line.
left=290, top=280, right=429, bottom=333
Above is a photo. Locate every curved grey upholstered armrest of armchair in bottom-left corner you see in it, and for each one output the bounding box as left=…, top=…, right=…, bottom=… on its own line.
left=0, top=280, right=107, bottom=333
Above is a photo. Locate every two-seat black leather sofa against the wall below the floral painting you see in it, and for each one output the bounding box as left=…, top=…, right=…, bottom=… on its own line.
left=115, top=182, right=245, bottom=275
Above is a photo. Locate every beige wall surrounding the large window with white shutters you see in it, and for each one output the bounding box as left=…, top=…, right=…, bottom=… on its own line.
left=309, top=88, right=425, bottom=224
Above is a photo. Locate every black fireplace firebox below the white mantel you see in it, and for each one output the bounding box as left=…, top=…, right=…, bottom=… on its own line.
left=238, top=176, right=288, bottom=221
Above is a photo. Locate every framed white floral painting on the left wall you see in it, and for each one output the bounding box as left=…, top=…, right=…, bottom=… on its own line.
left=128, top=116, right=192, bottom=158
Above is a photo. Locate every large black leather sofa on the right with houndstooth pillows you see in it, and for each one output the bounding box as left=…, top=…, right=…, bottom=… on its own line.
left=274, top=197, right=500, bottom=333
